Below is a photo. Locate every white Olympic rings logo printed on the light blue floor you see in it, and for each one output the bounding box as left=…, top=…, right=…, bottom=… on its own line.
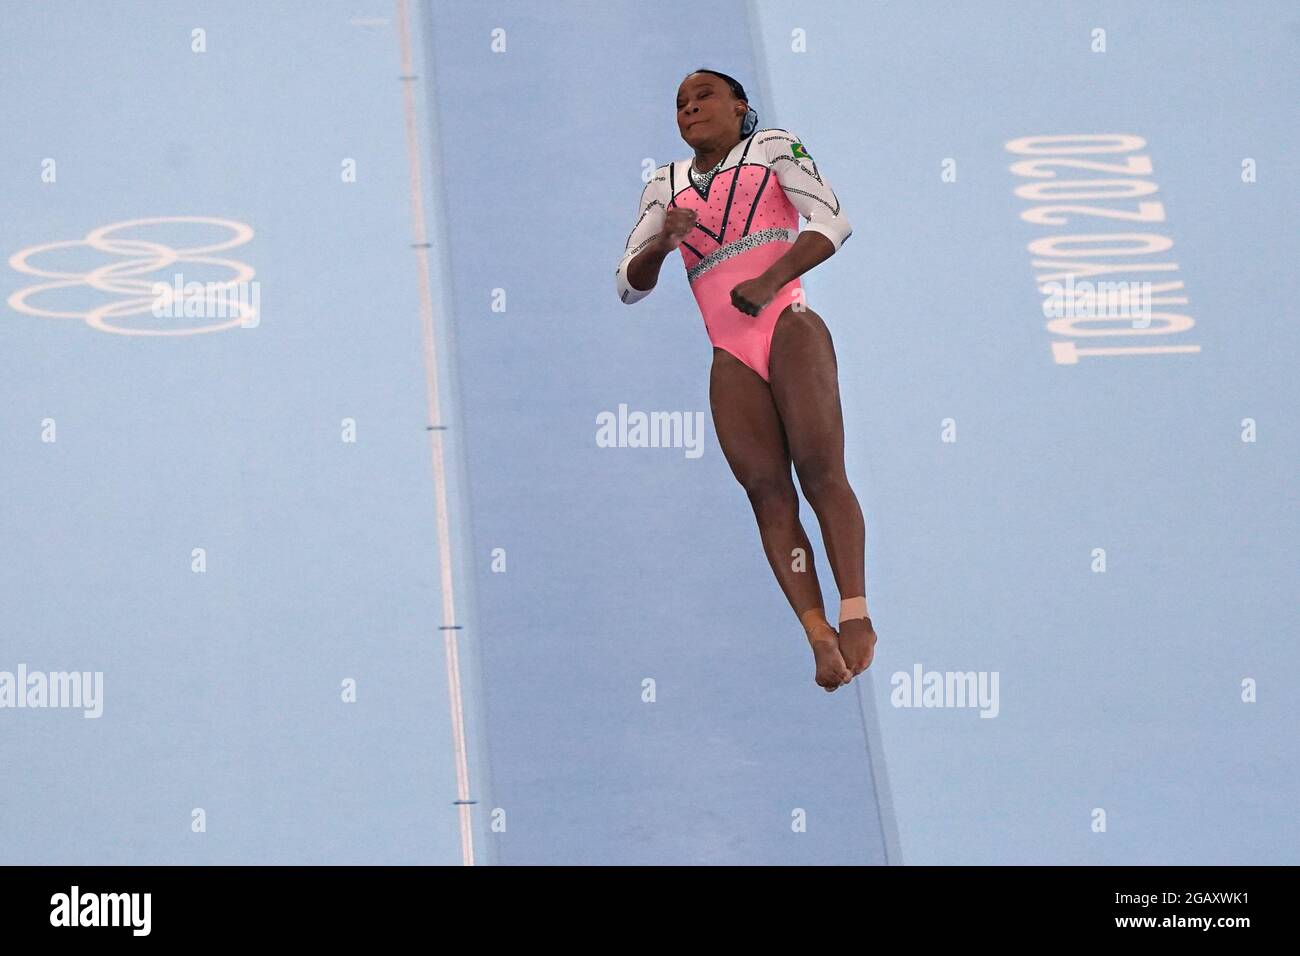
left=9, top=216, right=257, bottom=336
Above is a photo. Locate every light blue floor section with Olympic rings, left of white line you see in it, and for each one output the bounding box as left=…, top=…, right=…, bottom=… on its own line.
left=0, top=3, right=493, bottom=864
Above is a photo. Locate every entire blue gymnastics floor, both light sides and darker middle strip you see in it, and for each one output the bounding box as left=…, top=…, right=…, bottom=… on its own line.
left=0, top=0, right=1300, bottom=864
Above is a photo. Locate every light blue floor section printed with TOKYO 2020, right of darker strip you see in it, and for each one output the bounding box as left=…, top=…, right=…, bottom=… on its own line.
left=758, top=3, right=1300, bottom=864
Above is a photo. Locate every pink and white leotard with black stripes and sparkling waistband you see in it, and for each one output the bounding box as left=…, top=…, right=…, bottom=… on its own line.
left=616, top=129, right=853, bottom=381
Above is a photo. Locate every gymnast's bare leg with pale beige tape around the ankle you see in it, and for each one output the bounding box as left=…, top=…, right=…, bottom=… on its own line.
left=768, top=307, right=876, bottom=675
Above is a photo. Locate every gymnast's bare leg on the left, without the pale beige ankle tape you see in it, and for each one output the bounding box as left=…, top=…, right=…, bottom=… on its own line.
left=709, top=347, right=852, bottom=691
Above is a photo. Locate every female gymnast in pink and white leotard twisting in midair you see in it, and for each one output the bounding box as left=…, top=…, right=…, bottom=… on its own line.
left=618, top=69, right=876, bottom=691
